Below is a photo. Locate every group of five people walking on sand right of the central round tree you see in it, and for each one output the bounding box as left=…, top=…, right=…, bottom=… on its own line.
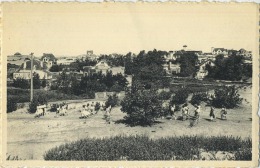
left=170, top=103, right=227, bottom=121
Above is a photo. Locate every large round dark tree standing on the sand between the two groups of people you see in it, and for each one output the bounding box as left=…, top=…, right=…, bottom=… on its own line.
left=121, top=86, right=162, bottom=126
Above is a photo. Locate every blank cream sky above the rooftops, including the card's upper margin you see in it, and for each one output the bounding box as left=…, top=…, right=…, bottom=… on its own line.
left=2, top=3, right=258, bottom=56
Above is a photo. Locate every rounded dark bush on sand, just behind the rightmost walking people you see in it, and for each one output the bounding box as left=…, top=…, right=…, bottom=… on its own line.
left=211, top=85, right=242, bottom=108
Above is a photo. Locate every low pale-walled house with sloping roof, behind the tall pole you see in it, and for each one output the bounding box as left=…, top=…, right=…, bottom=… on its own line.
left=13, top=59, right=52, bottom=79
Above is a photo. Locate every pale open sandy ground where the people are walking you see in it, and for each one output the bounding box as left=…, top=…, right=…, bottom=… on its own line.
left=7, top=88, right=252, bottom=160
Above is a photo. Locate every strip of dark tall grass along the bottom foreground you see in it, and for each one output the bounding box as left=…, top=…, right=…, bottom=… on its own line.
left=44, top=135, right=252, bottom=160
